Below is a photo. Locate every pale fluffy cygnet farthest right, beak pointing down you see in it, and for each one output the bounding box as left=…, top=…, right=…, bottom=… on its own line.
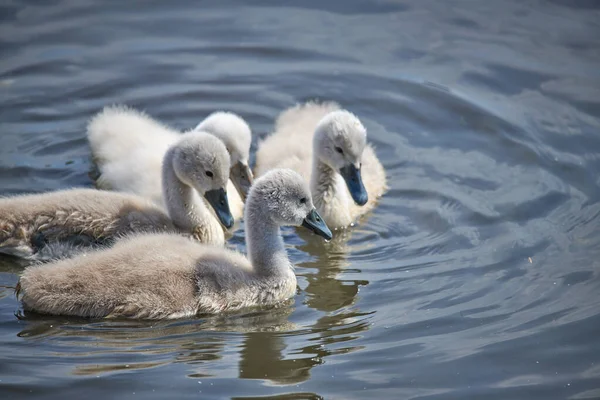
left=255, top=102, right=388, bottom=228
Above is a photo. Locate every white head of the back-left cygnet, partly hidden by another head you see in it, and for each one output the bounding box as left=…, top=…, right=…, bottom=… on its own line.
left=194, top=111, right=254, bottom=200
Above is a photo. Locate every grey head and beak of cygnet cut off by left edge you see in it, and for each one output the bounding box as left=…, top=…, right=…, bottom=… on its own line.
left=171, top=131, right=234, bottom=229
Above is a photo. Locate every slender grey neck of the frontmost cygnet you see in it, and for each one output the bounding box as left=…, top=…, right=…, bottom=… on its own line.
left=245, top=196, right=293, bottom=275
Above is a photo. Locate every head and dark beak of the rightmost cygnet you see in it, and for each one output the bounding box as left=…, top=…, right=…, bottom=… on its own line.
left=313, top=110, right=369, bottom=206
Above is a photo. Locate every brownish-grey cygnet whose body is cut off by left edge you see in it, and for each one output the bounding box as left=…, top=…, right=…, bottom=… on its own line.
left=0, top=132, right=233, bottom=261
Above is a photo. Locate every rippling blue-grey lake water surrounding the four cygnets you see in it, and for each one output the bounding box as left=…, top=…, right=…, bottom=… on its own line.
left=0, top=0, right=600, bottom=399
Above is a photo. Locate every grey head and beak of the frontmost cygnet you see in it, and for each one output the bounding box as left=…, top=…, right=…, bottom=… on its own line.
left=245, top=169, right=332, bottom=240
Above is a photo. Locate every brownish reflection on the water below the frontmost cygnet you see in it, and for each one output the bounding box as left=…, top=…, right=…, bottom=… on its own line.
left=11, top=294, right=370, bottom=385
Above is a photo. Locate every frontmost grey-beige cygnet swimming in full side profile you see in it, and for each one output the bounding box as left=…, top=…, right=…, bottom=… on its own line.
left=15, top=169, right=331, bottom=319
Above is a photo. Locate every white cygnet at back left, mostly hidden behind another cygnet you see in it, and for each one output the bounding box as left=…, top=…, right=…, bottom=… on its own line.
left=87, top=105, right=253, bottom=219
